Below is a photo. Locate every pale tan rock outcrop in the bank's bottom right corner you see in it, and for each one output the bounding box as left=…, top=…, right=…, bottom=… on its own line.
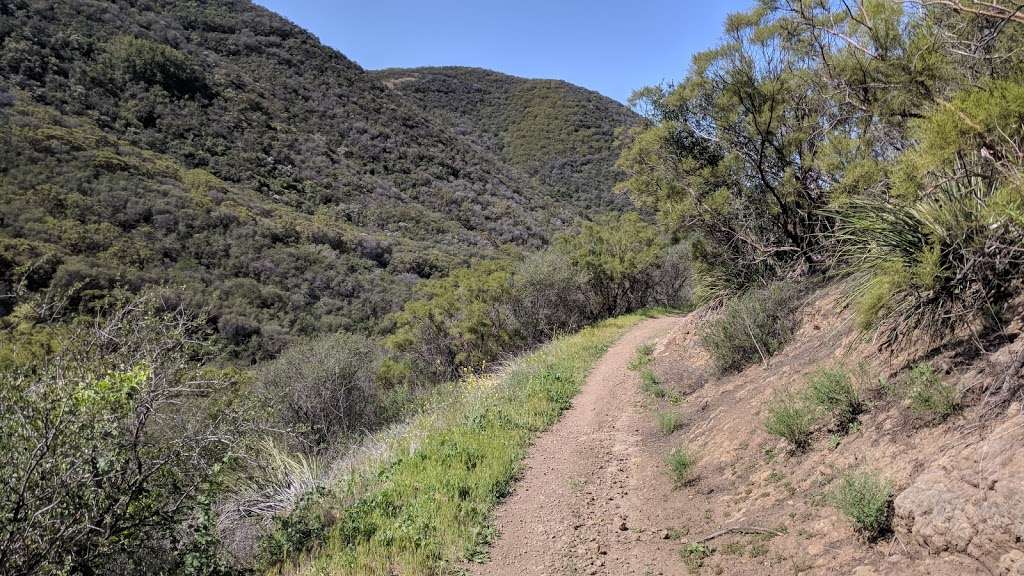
left=895, top=408, right=1024, bottom=576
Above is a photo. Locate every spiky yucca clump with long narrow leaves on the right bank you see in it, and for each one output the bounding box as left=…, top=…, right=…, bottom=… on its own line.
left=833, top=180, right=1024, bottom=346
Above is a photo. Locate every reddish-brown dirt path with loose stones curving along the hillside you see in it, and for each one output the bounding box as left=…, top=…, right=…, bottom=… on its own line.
left=471, top=317, right=686, bottom=576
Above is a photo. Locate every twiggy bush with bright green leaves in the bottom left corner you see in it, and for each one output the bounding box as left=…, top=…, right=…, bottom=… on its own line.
left=0, top=300, right=247, bottom=575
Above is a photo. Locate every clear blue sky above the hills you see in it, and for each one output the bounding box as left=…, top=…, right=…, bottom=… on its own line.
left=256, top=0, right=754, bottom=101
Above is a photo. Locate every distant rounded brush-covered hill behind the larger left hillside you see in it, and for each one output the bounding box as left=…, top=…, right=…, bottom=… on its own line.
left=372, top=67, right=638, bottom=208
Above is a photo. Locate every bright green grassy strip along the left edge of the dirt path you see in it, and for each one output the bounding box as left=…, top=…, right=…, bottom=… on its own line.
left=276, top=315, right=642, bottom=574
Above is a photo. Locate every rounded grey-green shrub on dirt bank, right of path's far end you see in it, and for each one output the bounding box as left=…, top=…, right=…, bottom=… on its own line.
left=700, top=284, right=797, bottom=372
